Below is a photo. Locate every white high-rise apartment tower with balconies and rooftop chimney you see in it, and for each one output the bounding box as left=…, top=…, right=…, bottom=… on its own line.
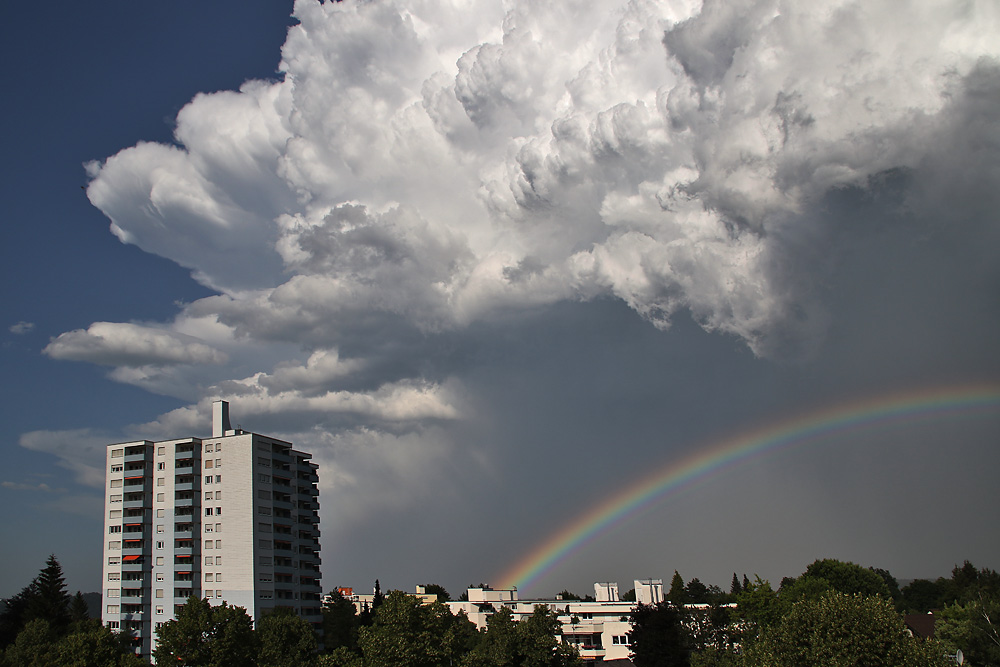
left=102, top=401, right=322, bottom=656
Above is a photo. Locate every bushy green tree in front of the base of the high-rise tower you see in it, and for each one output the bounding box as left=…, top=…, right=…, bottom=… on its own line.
left=153, top=596, right=257, bottom=667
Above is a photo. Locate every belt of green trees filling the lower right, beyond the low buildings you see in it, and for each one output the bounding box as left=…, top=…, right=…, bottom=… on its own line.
left=630, top=559, right=1000, bottom=667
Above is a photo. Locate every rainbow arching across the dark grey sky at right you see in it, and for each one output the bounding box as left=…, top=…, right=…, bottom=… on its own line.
left=499, top=384, right=1000, bottom=590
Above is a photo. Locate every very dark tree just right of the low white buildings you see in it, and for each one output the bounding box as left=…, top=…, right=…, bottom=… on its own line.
left=628, top=604, right=691, bottom=667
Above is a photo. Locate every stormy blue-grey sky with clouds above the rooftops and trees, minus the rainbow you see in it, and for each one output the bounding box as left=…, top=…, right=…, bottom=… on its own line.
left=0, top=0, right=1000, bottom=597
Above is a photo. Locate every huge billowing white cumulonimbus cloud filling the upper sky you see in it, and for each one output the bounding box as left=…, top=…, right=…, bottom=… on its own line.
left=80, top=0, right=997, bottom=356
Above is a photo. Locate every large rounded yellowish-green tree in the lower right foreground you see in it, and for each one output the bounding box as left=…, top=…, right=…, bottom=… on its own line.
left=745, top=591, right=948, bottom=667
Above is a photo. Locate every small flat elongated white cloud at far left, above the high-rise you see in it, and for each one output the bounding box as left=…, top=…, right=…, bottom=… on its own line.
left=43, top=322, right=226, bottom=368
